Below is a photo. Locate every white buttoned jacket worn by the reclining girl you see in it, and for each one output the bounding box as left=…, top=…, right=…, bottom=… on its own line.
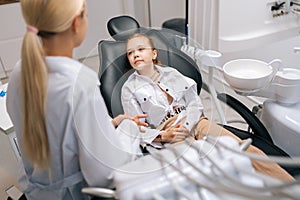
left=121, top=65, right=203, bottom=131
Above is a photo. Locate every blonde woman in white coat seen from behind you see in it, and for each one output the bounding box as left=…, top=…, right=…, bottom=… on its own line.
left=7, top=0, right=143, bottom=200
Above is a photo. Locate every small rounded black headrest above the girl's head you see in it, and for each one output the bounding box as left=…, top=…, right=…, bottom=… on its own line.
left=107, top=15, right=140, bottom=41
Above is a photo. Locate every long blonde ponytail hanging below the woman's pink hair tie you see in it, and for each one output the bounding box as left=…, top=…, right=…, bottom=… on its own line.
left=21, top=32, right=50, bottom=168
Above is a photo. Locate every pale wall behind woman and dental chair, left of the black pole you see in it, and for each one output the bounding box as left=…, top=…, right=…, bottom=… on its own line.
left=0, top=0, right=185, bottom=79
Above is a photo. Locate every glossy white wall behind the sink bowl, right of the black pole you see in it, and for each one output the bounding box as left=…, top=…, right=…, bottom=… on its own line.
left=189, top=0, right=300, bottom=69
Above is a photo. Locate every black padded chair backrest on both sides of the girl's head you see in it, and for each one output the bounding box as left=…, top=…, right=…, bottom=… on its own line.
left=98, top=29, right=202, bottom=117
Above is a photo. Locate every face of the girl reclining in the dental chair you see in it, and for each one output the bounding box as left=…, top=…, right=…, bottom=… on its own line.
left=126, top=36, right=157, bottom=71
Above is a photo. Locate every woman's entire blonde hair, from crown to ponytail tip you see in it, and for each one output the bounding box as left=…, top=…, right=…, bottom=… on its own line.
left=21, top=0, right=85, bottom=168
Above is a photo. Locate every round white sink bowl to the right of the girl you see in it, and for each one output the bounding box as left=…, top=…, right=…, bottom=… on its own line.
left=223, top=59, right=273, bottom=91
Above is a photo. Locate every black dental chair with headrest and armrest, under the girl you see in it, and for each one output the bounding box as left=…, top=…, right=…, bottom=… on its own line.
left=98, top=16, right=300, bottom=175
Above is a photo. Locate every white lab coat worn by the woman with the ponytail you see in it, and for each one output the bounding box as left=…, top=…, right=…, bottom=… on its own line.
left=7, top=57, right=139, bottom=200
